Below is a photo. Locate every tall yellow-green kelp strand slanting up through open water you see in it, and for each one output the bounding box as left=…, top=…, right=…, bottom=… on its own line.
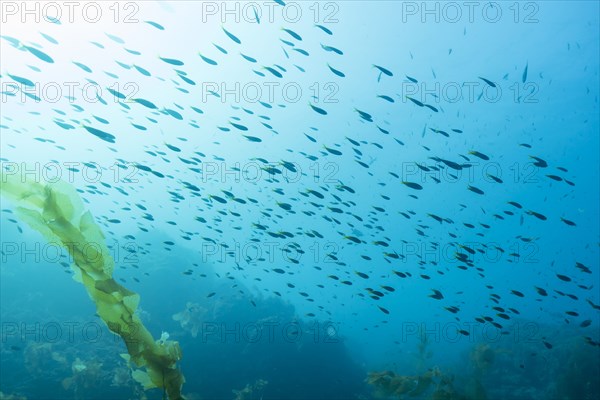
left=0, top=171, right=185, bottom=400
